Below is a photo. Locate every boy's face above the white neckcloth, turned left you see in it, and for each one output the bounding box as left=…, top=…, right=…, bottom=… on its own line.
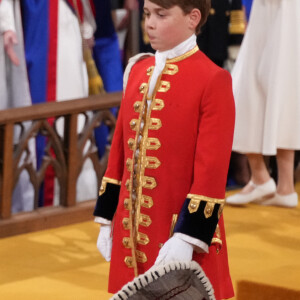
left=144, top=0, right=195, bottom=51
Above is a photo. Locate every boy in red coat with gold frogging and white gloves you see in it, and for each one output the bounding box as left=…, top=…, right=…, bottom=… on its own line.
left=94, top=0, right=235, bottom=299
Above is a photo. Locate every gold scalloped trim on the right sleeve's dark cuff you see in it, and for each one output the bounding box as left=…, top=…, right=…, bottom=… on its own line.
left=187, top=194, right=225, bottom=218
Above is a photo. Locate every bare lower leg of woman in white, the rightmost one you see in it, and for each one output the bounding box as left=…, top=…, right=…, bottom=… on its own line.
left=276, top=149, right=295, bottom=195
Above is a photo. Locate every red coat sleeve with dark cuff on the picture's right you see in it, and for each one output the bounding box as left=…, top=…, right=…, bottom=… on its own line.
left=174, top=70, right=235, bottom=245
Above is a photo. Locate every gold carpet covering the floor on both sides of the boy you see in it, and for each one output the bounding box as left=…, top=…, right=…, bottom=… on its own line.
left=0, top=185, right=300, bottom=300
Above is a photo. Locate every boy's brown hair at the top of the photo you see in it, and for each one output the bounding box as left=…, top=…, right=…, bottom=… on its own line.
left=150, top=0, right=211, bottom=34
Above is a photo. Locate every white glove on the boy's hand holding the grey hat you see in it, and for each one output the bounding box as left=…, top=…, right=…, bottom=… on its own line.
left=154, top=236, right=194, bottom=265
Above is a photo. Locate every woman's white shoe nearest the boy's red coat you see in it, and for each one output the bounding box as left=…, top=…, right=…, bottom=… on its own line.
left=226, top=178, right=276, bottom=205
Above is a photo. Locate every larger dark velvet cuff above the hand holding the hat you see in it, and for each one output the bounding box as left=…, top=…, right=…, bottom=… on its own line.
left=174, top=198, right=220, bottom=246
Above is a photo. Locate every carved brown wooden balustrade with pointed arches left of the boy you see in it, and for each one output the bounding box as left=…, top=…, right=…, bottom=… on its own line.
left=0, top=93, right=121, bottom=237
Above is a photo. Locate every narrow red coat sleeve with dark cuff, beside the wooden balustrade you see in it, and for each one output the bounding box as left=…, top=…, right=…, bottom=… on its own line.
left=94, top=101, right=124, bottom=220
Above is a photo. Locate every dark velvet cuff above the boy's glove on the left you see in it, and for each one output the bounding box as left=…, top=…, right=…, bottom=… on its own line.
left=94, top=182, right=121, bottom=221
